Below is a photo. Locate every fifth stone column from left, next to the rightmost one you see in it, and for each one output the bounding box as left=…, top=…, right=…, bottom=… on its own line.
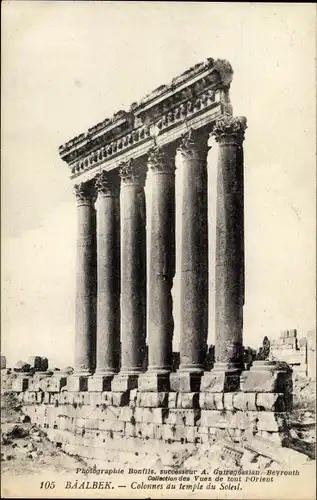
left=170, top=130, right=209, bottom=392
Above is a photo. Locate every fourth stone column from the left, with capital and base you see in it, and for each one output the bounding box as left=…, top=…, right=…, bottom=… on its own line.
left=138, top=146, right=176, bottom=392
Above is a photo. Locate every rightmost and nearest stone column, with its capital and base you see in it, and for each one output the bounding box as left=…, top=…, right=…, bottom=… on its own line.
left=201, top=115, right=246, bottom=392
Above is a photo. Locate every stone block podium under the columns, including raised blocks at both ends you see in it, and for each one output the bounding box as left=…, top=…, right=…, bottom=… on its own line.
left=3, top=361, right=292, bottom=460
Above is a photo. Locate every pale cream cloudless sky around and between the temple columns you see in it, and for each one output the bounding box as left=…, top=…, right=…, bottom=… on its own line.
left=1, top=1, right=316, bottom=366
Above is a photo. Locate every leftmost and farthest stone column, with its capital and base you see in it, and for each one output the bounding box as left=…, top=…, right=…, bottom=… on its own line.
left=67, top=182, right=97, bottom=391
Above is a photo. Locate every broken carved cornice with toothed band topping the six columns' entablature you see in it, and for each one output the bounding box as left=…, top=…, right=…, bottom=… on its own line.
left=59, top=58, right=233, bottom=177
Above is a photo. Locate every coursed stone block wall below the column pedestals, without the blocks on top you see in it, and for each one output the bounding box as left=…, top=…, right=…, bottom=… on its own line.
left=19, top=384, right=288, bottom=459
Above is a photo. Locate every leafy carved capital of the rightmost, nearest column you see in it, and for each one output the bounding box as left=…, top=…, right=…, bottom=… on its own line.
left=212, top=115, right=247, bottom=144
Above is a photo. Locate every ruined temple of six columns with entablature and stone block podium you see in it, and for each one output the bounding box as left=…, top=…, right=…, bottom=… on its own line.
left=2, top=58, right=310, bottom=463
